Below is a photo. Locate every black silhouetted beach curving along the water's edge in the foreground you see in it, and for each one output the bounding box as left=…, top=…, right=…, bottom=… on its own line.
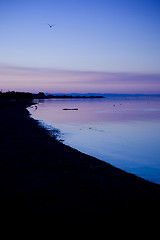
left=0, top=100, right=160, bottom=232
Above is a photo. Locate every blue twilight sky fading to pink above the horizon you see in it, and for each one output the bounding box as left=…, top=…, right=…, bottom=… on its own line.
left=0, top=0, right=160, bottom=93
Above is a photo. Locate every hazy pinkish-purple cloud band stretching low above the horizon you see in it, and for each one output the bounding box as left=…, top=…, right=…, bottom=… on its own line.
left=0, top=63, right=160, bottom=93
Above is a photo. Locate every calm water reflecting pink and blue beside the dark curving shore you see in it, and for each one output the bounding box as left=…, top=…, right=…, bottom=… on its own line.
left=29, top=98, right=160, bottom=184
